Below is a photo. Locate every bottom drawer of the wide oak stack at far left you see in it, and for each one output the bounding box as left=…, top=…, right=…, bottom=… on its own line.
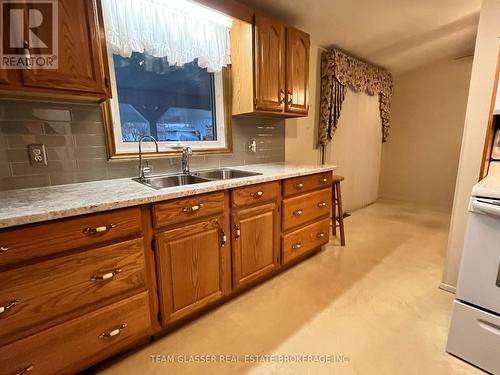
left=0, top=292, right=151, bottom=375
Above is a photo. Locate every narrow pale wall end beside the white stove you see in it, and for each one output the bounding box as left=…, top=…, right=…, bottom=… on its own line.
left=443, top=0, right=500, bottom=288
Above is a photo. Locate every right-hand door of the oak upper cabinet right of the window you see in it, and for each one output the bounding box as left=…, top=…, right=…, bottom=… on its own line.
left=285, top=27, right=310, bottom=114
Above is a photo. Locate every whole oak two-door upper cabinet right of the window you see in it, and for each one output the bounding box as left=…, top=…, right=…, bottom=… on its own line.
left=230, top=13, right=310, bottom=118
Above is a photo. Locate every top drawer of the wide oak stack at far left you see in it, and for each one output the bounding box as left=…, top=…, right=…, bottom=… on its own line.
left=0, top=207, right=142, bottom=266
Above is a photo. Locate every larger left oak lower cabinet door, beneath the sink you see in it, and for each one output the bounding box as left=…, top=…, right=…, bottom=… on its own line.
left=155, top=217, right=230, bottom=325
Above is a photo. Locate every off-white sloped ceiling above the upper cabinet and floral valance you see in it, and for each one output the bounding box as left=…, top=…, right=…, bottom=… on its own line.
left=240, top=0, right=481, bottom=75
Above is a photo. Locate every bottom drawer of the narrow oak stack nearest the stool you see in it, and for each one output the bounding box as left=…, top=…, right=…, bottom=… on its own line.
left=283, top=219, right=330, bottom=264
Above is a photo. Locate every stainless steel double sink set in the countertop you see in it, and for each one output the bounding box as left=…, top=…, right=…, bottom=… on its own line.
left=133, top=168, right=262, bottom=190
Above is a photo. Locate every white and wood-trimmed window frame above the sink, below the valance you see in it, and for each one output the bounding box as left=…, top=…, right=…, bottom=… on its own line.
left=101, top=54, right=233, bottom=160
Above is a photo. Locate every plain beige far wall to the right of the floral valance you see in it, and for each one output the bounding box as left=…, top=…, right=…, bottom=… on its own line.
left=380, top=57, right=472, bottom=211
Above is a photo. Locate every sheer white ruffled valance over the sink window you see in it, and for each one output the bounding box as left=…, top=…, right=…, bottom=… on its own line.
left=103, top=0, right=232, bottom=72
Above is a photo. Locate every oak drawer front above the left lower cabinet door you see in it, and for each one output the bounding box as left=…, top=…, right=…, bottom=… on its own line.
left=153, top=192, right=225, bottom=228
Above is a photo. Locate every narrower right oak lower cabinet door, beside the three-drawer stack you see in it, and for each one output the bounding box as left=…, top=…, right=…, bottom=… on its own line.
left=232, top=202, right=280, bottom=288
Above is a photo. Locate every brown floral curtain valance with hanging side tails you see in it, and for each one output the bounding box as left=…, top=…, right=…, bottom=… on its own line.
left=318, top=49, right=392, bottom=145
